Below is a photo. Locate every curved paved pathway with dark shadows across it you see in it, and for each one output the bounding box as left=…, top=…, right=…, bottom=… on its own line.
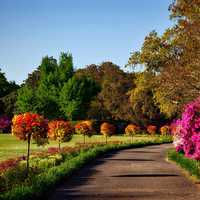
left=49, top=144, right=200, bottom=200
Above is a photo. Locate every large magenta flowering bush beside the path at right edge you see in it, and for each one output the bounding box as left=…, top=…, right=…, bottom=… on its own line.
left=171, top=97, right=200, bottom=160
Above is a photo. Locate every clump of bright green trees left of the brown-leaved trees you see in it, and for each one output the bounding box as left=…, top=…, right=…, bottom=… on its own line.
left=16, top=53, right=99, bottom=119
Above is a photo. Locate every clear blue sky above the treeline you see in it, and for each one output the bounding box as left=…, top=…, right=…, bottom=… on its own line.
left=0, top=0, right=172, bottom=83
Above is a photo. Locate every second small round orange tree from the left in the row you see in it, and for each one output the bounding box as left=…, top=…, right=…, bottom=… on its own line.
left=48, top=120, right=74, bottom=149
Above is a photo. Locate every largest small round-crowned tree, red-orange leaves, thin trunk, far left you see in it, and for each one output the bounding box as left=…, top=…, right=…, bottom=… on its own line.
left=12, top=113, right=48, bottom=175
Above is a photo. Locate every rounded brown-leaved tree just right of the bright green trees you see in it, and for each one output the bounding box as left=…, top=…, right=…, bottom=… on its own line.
left=76, top=62, right=134, bottom=120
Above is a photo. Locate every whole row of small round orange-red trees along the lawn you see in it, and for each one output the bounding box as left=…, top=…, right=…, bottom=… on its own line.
left=12, top=113, right=172, bottom=175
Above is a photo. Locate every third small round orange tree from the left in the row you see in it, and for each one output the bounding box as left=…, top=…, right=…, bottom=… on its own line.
left=75, top=121, right=93, bottom=144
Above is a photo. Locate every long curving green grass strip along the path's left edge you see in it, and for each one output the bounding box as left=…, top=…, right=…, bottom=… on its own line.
left=0, top=137, right=171, bottom=200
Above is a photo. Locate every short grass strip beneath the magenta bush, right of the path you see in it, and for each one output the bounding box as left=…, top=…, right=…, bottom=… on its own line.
left=168, top=150, right=200, bottom=180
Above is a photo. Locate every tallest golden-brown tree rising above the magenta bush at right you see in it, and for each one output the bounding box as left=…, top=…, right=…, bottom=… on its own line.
left=128, top=0, right=200, bottom=119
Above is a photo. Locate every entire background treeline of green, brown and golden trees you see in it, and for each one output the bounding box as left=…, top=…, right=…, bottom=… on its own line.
left=0, top=0, right=200, bottom=126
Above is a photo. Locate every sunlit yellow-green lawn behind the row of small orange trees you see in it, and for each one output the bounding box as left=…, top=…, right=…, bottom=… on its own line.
left=0, top=134, right=150, bottom=161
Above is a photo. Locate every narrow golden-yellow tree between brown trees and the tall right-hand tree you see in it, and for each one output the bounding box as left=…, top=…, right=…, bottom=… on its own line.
left=130, top=72, right=164, bottom=126
